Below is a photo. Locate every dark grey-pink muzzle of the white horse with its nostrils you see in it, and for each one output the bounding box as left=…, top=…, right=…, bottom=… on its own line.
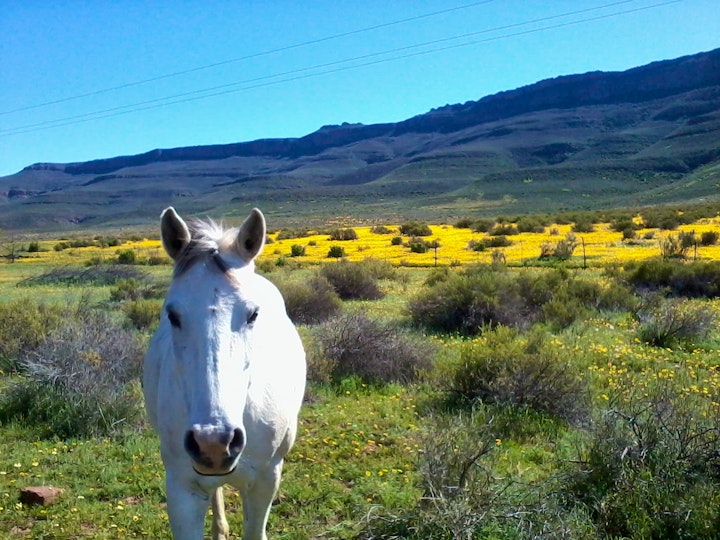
left=185, top=424, right=245, bottom=476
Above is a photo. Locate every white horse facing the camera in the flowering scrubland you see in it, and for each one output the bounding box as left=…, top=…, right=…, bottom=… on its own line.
left=143, top=208, right=305, bottom=540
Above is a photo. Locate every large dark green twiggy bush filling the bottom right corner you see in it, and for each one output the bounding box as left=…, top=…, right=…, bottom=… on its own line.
left=565, top=386, right=720, bottom=540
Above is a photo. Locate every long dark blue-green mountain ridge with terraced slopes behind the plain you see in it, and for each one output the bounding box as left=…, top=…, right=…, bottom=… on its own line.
left=0, top=49, right=720, bottom=229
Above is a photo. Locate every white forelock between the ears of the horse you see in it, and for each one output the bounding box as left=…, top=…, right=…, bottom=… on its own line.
left=174, top=219, right=243, bottom=276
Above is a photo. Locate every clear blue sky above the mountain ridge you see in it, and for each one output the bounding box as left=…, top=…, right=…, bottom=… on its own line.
left=0, top=0, right=720, bottom=176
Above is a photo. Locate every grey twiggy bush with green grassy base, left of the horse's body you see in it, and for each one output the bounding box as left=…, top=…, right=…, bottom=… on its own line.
left=0, top=307, right=143, bottom=438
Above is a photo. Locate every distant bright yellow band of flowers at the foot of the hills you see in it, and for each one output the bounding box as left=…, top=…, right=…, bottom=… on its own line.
left=14, top=218, right=720, bottom=267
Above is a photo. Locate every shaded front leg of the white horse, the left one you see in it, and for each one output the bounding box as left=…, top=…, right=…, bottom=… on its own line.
left=165, top=471, right=210, bottom=540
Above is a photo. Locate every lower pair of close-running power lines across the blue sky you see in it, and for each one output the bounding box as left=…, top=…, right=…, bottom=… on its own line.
left=0, top=0, right=683, bottom=137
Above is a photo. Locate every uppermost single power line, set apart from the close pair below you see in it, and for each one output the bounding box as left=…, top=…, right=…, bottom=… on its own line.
left=0, top=0, right=495, bottom=115
